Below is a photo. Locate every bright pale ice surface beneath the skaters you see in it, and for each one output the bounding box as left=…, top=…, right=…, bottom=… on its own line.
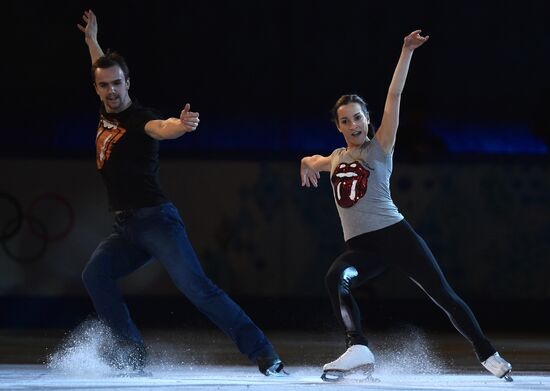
left=0, top=365, right=550, bottom=391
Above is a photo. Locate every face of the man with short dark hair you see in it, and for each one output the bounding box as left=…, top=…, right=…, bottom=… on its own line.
left=94, top=65, right=132, bottom=113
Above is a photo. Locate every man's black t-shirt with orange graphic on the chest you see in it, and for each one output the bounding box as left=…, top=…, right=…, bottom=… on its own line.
left=96, top=103, right=168, bottom=211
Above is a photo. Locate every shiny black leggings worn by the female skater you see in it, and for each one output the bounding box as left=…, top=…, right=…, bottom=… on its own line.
left=326, top=220, right=495, bottom=361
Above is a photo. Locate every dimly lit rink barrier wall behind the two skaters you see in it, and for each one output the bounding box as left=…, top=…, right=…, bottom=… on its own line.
left=0, top=160, right=550, bottom=299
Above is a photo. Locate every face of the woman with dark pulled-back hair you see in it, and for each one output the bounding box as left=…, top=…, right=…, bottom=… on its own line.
left=336, top=103, right=369, bottom=147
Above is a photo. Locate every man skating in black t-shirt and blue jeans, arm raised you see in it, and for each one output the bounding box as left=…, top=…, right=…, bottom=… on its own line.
left=78, top=10, right=284, bottom=375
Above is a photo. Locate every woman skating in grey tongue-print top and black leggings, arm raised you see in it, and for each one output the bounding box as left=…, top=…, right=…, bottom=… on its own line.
left=300, top=30, right=512, bottom=381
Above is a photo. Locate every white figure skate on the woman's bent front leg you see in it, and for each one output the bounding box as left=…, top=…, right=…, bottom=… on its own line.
left=321, top=345, right=374, bottom=382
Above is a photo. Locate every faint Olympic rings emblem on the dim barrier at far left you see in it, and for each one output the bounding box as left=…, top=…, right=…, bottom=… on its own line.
left=0, top=193, right=75, bottom=264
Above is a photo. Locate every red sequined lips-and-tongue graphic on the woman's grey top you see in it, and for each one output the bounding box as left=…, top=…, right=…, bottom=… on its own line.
left=331, top=161, right=370, bottom=208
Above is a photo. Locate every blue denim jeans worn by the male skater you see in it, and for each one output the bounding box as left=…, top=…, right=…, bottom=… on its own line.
left=82, top=203, right=272, bottom=361
